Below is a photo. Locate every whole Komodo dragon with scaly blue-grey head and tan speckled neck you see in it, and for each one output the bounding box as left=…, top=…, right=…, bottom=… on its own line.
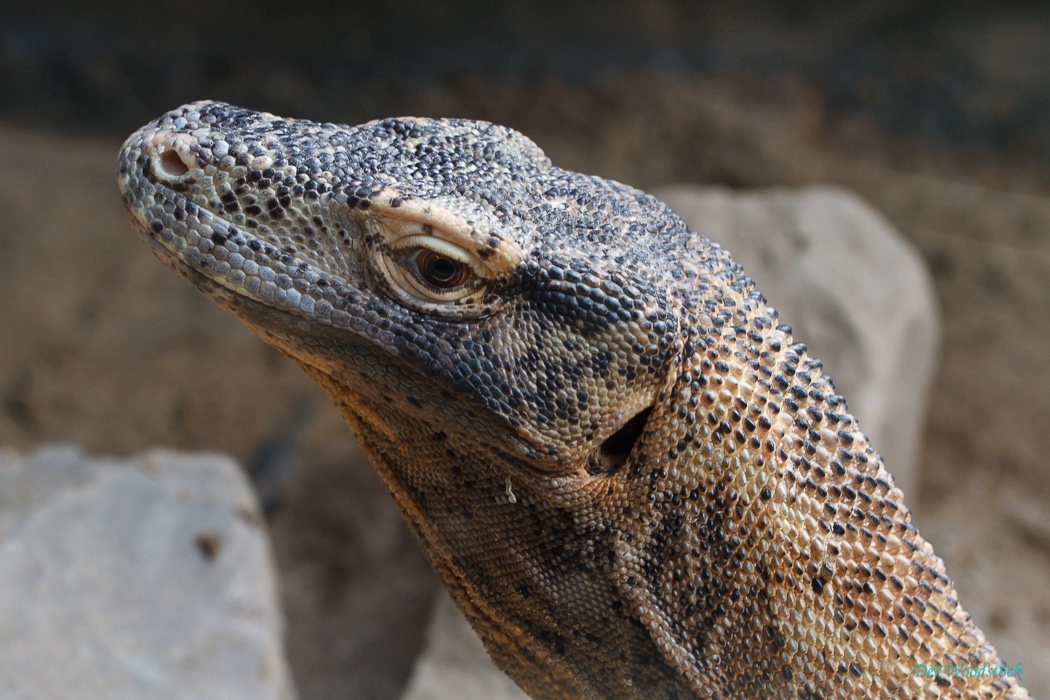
left=119, top=102, right=1028, bottom=700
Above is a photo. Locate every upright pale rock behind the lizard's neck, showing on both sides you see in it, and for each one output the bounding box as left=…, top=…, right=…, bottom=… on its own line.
left=402, top=186, right=940, bottom=700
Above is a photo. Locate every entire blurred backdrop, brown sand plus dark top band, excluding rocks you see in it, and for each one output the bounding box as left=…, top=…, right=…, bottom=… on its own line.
left=0, top=0, right=1050, bottom=700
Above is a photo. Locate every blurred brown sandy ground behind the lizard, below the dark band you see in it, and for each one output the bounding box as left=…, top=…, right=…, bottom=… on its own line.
left=0, top=76, right=1050, bottom=700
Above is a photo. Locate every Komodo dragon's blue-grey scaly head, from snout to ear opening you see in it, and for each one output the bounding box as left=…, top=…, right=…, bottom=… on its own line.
left=119, top=102, right=716, bottom=482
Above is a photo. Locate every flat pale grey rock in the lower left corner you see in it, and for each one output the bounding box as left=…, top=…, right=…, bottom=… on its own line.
left=0, top=448, right=295, bottom=700
